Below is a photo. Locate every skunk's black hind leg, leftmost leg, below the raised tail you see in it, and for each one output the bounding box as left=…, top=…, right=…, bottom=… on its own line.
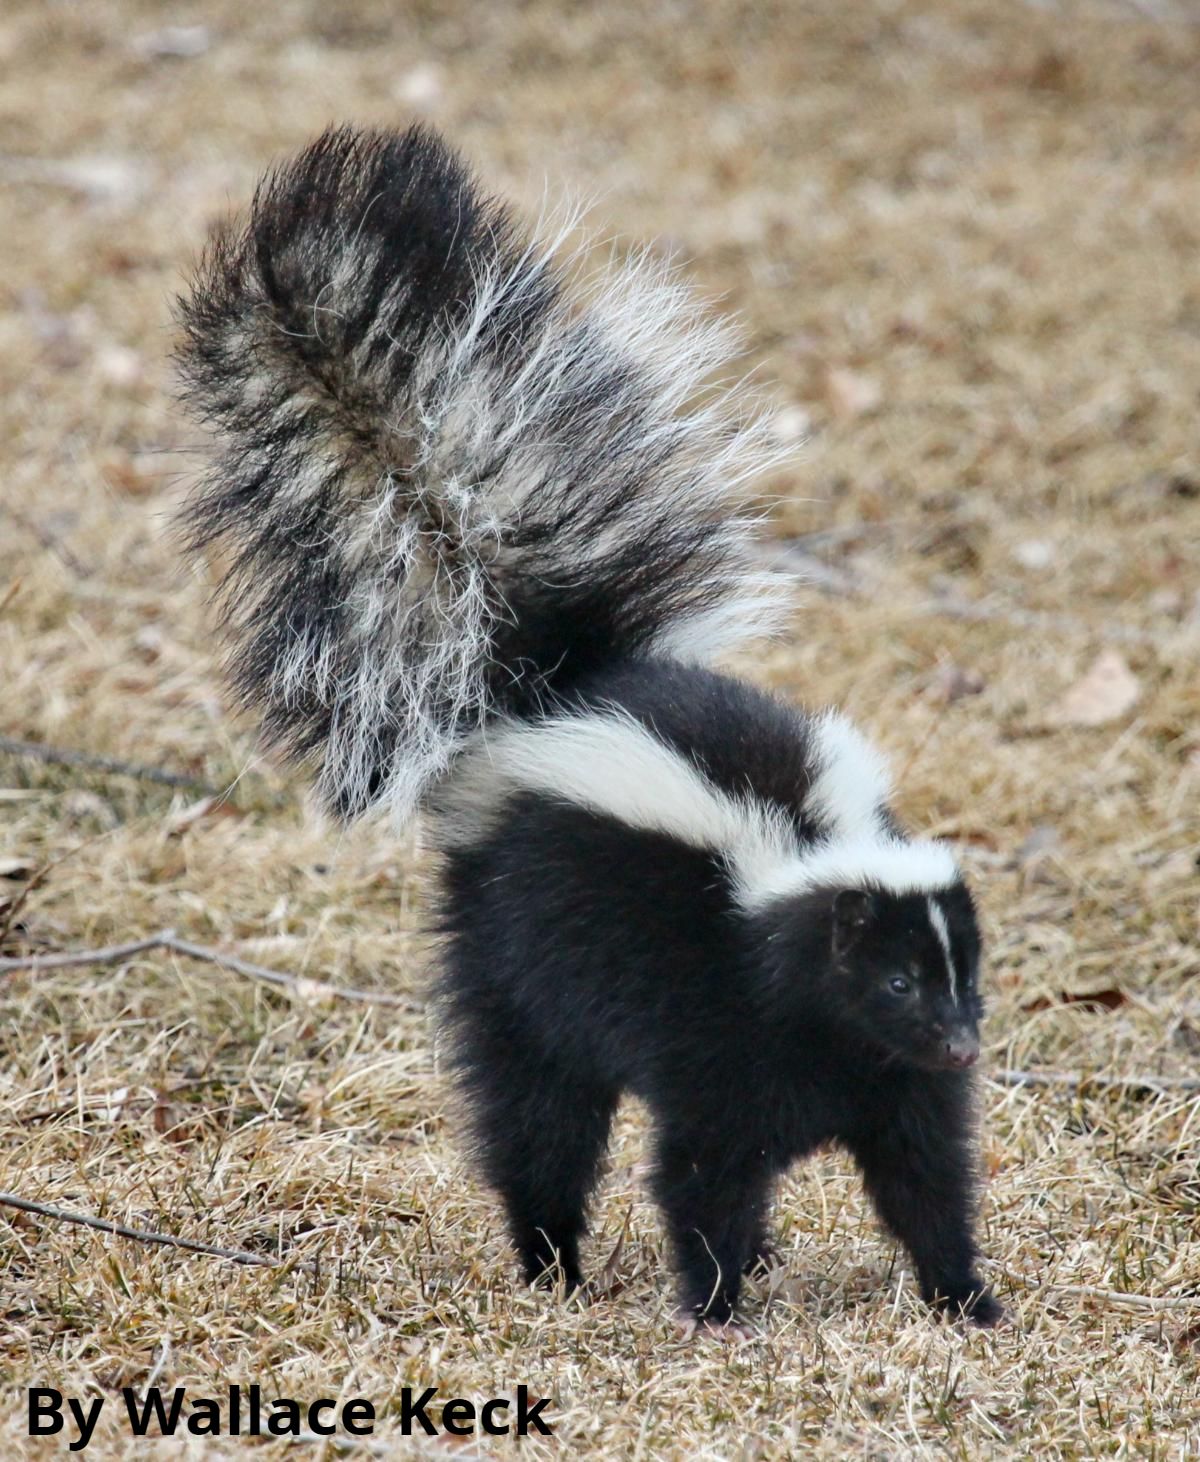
left=462, top=1028, right=617, bottom=1294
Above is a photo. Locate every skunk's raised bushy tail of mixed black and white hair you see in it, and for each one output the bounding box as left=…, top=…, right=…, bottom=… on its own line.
left=178, top=127, right=781, bottom=816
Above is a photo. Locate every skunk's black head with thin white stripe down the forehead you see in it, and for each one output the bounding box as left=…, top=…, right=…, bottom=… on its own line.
left=830, top=883, right=982, bottom=1070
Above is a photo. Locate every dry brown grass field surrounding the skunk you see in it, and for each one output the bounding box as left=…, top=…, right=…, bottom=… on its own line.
left=0, top=0, right=1200, bottom=1459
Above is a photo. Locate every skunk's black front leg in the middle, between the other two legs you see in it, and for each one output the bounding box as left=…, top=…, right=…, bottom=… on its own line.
left=653, top=1126, right=770, bottom=1326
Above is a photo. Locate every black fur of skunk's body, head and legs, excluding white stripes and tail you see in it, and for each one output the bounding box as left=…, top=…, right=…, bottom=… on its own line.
left=441, top=662, right=1001, bottom=1325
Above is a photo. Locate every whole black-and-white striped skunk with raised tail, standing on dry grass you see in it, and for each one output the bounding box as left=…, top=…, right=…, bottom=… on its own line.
left=178, top=127, right=1001, bottom=1327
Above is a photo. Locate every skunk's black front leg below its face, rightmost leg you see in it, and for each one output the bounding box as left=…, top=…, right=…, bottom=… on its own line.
left=848, top=1072, right=1004, bottom=1326
